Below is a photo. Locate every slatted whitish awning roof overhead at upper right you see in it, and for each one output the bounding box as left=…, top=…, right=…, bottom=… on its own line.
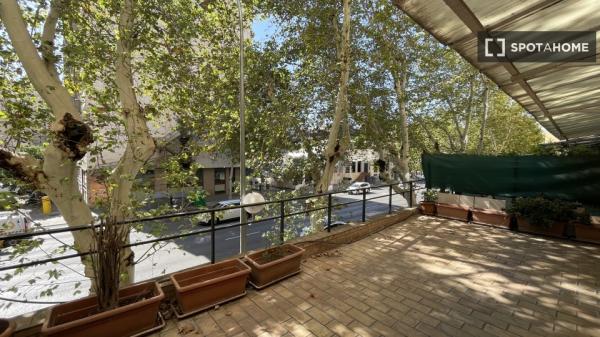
left=393, top=0, right=600, bottom=140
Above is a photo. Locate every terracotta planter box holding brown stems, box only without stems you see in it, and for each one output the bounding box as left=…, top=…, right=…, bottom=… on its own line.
left=42, top=282, right=165, bottom=337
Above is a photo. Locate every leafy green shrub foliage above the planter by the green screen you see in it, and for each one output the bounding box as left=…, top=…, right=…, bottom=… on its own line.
left=509, top=197, right=578, bottom=228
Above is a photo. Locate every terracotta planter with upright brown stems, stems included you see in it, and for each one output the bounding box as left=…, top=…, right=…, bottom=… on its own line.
left=42, top=222, right=164, bottom=337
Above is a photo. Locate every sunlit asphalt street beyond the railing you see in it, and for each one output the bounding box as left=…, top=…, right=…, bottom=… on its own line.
left=0, top=187, right=418, bottom=317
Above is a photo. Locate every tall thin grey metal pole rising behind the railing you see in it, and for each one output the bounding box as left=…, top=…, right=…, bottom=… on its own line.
left=237, top=0, right=248, bottom=254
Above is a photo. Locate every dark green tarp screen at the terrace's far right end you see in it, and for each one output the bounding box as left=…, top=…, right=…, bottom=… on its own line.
left=422, top=154, right=600, bottom=205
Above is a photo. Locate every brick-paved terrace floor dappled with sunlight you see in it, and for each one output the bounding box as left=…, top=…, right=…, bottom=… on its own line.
left=153, top=216, right=600, bottom=337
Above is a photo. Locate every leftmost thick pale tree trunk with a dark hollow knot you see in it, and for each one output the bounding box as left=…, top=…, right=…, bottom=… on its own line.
left=0, top=0, right=94, bottom=280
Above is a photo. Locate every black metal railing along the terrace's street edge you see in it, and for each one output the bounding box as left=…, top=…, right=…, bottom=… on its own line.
left=0, top=180, right=425, bottom=272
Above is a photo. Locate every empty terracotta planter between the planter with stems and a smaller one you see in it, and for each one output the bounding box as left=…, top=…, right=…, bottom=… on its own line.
left=171, top=259, right=250, bottom=315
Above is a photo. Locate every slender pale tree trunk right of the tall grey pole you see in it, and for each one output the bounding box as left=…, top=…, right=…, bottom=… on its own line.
left=315, top=0, right=351, bottom=193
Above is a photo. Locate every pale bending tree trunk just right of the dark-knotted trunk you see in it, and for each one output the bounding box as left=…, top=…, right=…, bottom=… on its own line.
left=109, top=0, right=156, bottom=283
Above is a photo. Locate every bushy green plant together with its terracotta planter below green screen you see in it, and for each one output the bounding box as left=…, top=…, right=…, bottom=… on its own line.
left=510, top=197, right=576, bottom=237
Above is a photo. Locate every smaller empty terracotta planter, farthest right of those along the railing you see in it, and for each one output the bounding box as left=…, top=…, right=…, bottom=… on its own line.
left=246, top=244, right=304, bottom=289
